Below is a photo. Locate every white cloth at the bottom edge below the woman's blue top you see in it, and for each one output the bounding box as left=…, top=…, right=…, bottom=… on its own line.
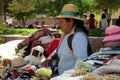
left=50, top=70, right=83, bottom=80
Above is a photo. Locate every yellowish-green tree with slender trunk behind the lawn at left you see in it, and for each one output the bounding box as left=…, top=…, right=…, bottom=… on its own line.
left=8, top=0, right=36, bottom=27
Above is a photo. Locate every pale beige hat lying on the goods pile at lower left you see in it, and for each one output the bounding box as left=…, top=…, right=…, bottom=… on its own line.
left=12, top=57, right=27, bottom=69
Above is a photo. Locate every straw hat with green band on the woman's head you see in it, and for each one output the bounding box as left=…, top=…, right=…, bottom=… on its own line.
left=56, top=4, right=80, bottom=20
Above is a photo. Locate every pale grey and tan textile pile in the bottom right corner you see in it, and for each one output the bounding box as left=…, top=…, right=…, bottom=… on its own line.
left=80, top=55, right=120, bottom=80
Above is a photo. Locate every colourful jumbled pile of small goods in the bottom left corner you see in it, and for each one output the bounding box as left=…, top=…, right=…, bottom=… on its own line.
left=0, top=57, right=52, bottom=80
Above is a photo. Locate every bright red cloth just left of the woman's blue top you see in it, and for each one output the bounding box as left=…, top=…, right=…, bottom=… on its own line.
left=45, top=38, right=60, bottom=56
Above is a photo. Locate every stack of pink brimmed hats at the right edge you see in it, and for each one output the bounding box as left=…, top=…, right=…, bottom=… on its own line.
left=103, top=25, right=120, bottom=46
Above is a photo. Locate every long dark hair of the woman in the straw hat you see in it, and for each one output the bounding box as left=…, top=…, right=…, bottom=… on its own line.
left=65, top=18, right=89, bottom=36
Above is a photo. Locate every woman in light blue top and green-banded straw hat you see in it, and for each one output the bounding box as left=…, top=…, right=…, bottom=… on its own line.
left=42, top=4, right=88, bottom=75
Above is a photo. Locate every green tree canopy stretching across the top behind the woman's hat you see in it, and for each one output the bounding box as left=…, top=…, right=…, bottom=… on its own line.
left=4, top=0, right=120, bottom=26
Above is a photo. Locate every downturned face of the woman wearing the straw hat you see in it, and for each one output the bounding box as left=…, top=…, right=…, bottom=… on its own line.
left=59, top=18, right=73, bottom=34
